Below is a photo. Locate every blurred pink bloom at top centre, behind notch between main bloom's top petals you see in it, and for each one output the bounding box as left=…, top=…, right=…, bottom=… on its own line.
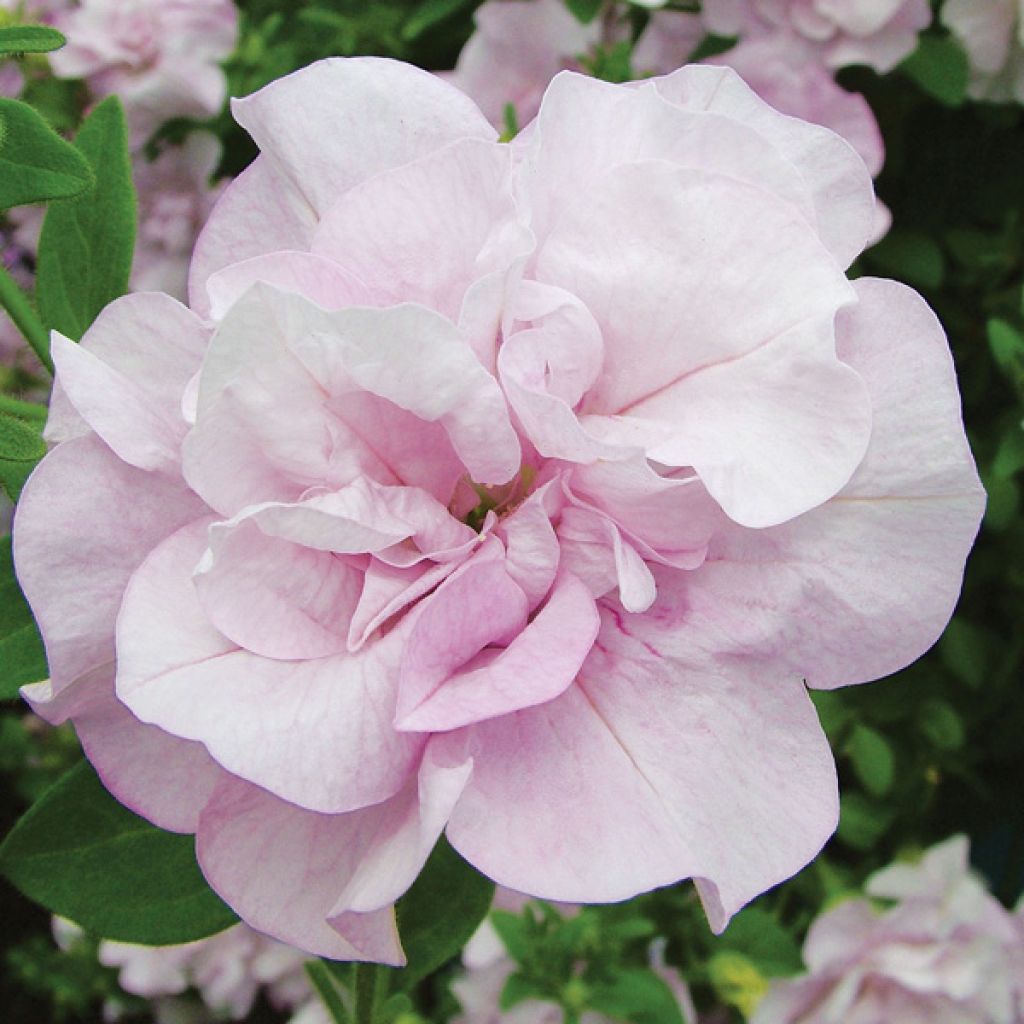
left=444, top=0, right=601, bottom=127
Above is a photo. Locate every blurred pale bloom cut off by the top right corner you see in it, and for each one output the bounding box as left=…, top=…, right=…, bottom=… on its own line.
left=942, top=0, right=1024, bottom=103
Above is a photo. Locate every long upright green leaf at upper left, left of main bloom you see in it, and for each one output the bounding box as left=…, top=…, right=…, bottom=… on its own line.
left=36, top=96, right=135, bottom=341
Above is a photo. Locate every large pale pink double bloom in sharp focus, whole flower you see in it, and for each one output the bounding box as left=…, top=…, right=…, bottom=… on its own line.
left=14, top=58, right=984, bottom=963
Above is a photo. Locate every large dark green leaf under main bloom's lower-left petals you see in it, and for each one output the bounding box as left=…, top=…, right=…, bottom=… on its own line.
left=0, top=761, right=238, bottom=945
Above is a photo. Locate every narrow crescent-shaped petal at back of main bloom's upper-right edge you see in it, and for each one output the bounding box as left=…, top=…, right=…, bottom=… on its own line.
left=654, top=65, right=873, bottom=267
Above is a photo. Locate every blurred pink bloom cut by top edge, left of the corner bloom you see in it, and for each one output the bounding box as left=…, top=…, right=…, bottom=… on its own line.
left=701, top=0, right=932, bottom=72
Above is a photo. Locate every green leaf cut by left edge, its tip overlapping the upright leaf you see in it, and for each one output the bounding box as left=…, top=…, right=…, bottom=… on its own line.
left=0, top=98, right=95, bottom=210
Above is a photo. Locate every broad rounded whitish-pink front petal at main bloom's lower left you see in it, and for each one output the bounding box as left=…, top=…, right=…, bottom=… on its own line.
left=117, top=522, right=422, bottom=812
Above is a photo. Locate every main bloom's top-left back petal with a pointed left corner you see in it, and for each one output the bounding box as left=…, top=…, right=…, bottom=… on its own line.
left=231, top=57, right=496, bottom=215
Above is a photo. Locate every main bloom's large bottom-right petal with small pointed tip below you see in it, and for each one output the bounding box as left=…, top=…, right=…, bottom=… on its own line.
left=444, top=602, right=838, bottom=931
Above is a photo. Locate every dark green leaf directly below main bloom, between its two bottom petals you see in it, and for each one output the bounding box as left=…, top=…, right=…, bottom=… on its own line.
left=395, top=837, right=495, bottom=988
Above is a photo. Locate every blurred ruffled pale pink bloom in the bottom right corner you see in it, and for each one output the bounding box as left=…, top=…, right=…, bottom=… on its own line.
left=751, top=836, right=1024, bottom=1024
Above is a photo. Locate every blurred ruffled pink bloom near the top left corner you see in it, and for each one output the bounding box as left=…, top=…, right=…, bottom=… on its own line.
left=50, top=0, right=238, bottom=147
